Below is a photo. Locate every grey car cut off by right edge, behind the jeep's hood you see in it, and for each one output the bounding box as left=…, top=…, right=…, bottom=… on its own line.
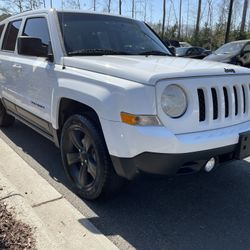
left=204, top=40, right=250, bottom=67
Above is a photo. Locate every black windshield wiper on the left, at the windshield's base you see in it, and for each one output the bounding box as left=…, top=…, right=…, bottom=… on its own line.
left=68, top=49, right=131, bottom=56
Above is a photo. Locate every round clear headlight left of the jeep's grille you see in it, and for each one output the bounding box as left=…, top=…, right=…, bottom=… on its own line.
left=161, top=84, right=187, bottom=118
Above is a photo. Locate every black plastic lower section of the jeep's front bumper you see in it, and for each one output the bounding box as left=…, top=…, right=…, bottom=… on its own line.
left=111, top=144, right=237, bottom=179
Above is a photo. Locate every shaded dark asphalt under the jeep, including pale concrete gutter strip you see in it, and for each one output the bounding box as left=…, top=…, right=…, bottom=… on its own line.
left=0, top=122, right=250, bottom=250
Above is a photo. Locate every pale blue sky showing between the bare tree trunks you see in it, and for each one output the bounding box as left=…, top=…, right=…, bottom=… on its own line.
left=0, top=0, right=250, bottom=27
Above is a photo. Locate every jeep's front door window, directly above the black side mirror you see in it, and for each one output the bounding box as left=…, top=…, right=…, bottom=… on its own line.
left=22, top=17, right=50, bottom=47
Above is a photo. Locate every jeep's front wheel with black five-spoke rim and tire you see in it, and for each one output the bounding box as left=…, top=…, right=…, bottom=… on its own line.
left=60, top=115, right=123, bottom=200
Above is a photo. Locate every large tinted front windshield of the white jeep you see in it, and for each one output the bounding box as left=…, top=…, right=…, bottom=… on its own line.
left=58, top=12, right=171, bottom=56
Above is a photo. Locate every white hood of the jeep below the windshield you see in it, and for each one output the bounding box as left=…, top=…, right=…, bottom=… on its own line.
left=63, top=55, right=250, bottom=85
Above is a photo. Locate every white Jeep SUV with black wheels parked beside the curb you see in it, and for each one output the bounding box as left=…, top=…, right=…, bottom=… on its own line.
left=0, top=9, right=250, bottom=199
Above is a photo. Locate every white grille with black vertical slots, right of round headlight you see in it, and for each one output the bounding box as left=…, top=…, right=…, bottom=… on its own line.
left=197, top=84, right=250, bottom=122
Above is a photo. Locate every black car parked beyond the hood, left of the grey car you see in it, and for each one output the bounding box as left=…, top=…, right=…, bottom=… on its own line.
left=176, top=47, right=211, bottom=59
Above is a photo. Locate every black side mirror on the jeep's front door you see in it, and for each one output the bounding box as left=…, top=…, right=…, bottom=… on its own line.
left=17, top=36, right=48, bottom=57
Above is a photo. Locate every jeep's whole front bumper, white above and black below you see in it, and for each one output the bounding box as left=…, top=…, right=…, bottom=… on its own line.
left=101, top=120, right=250, bottom=179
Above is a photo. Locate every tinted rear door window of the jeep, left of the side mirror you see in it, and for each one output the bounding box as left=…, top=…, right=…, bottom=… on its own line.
left=2, top=20, right=22, bottom=51
